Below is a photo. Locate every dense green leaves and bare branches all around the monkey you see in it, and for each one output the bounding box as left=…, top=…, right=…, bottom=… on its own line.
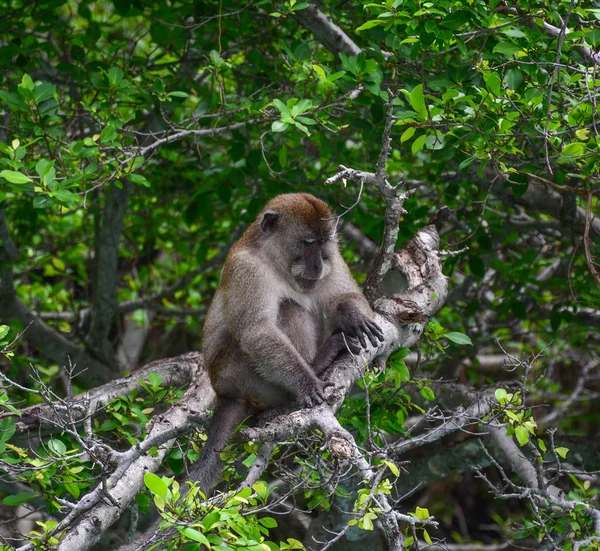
left=0, top=0, right=600, bottom=551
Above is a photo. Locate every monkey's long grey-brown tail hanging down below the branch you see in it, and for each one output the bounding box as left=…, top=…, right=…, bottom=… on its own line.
left=190, top=398, right=250, bottom=494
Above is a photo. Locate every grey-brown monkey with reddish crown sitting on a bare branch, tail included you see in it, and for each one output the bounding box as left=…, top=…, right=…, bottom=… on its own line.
left=190, top=193, right=383, bottom=494
